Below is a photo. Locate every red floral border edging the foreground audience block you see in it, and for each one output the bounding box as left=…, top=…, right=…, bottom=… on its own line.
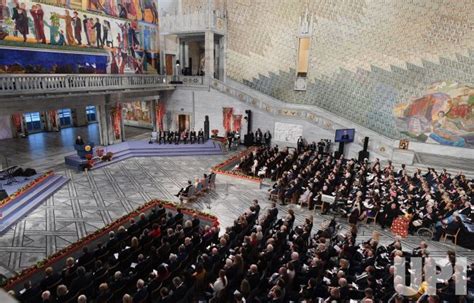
left=2, top=200, right=219, bottom=290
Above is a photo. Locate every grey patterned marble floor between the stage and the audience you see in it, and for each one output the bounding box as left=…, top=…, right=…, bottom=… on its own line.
left=0, top=155, right=474, bottom=276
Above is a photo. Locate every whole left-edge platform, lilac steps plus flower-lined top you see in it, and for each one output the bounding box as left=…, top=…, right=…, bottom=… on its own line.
left=0, top=172, right=69, bottom=234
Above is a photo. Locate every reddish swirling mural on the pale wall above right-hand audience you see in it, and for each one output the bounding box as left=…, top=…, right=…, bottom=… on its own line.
left=394, top=82, right=474, bottom=148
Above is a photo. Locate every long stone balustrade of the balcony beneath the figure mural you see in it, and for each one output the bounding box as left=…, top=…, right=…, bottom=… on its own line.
left=0, top=74, right=170, bottom=96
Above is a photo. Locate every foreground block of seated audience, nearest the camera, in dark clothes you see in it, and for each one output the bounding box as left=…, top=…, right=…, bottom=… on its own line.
left=6, top=201, right=474, bottom=303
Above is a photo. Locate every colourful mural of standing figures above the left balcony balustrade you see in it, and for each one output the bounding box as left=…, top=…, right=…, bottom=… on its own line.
left=0, top=0, right=159, bottom=74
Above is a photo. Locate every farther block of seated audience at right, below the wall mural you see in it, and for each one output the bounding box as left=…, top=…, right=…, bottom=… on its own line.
left=238, top=147, right=474, bottom=240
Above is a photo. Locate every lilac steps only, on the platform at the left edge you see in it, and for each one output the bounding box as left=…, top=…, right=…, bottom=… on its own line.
left=0, top=175, right=69, bottom=234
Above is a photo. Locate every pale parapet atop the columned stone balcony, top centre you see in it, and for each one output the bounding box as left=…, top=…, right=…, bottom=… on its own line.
left=160, top=10, right=226, bottom=34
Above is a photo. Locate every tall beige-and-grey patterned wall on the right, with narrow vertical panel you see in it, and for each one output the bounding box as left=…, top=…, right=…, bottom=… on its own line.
left=226, top=0, right=474, bottom=147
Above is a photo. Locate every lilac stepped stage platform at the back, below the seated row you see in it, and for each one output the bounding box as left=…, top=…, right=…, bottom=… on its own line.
left=65, top=140, right=223, bottom=169
